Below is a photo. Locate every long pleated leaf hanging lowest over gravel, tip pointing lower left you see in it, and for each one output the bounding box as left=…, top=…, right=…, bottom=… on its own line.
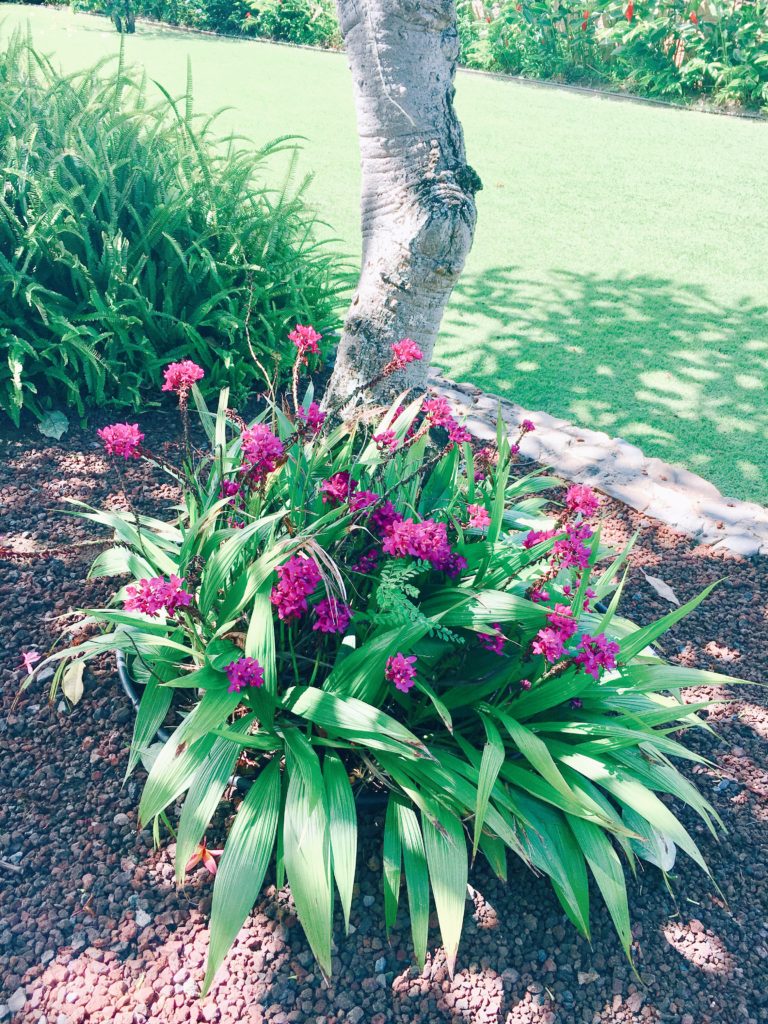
left=203, top=758, right=280, bottom=995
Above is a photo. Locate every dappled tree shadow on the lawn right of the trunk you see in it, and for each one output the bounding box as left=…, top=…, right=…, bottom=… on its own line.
left=438, top=267, right=768, bottom=503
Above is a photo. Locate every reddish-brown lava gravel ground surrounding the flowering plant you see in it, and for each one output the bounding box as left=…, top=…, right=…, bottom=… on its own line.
left=0, top=416, right=768, bottom=1024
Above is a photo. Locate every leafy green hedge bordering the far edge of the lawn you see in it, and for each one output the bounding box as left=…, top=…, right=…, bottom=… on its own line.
left=20, top=0, right=768, bottom=109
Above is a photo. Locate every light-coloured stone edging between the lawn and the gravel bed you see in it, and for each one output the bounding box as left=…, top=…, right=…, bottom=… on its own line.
left=430, top=370, right=768, bottom=558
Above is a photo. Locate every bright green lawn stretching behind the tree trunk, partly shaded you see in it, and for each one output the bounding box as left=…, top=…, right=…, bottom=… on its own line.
left=3, top=6, right=768, bottom=503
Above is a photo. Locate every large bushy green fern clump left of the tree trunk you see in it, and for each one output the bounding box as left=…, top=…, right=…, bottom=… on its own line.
left=0, top=32, right=339, bottom=424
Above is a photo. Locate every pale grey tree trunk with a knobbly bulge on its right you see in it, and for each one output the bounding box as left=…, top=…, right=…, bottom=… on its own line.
left=326, top=0, right=481, bottom=401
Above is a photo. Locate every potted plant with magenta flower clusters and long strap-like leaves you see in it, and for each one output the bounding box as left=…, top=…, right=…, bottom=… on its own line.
left=30, top=337, right=745, bottom=987
